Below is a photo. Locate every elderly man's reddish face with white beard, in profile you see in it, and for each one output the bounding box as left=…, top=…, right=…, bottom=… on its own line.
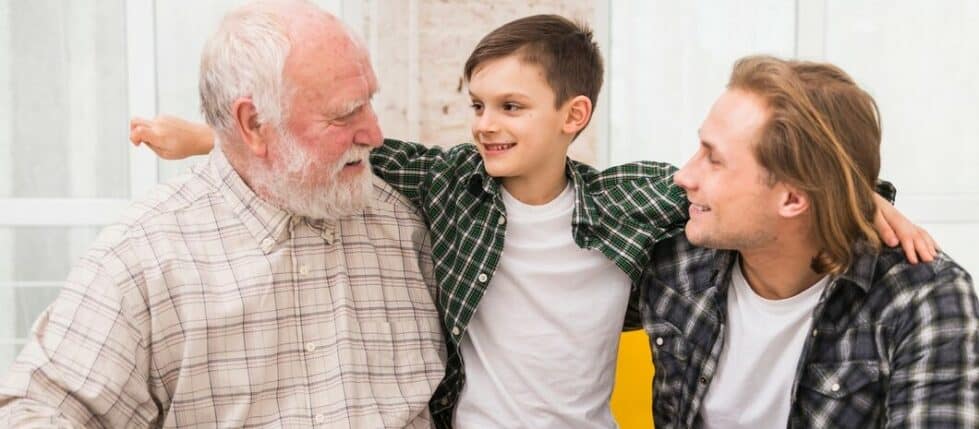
left=256, top=23, right=382, bottom=218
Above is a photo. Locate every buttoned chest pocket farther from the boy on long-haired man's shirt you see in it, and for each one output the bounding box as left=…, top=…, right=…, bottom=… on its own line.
left=799, top=361, right=884, bottom=427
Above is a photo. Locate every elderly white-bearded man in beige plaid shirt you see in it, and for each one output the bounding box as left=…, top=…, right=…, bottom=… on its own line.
left=0, top=2, right=444, bottom=428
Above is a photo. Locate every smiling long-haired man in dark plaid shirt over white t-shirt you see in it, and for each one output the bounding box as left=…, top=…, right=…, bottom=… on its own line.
left=642, top=57, right=979, bottom=429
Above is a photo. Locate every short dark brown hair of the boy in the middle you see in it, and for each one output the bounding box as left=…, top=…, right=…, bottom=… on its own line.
left=464, top=15, right=604, bottom=109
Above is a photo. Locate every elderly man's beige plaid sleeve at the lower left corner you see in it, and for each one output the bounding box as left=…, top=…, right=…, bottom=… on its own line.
left=0, top=231, right=159, bottom=427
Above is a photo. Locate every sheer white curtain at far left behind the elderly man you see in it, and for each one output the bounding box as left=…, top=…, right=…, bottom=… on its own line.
left=0, top=0, right=129, bottom=371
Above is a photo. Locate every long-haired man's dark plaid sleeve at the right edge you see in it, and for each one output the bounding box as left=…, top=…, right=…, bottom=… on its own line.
left=886, top=260, right=979, bottom=428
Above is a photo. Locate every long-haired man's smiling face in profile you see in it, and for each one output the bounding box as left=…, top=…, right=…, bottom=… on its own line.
left=674, top=90, right=778, bottom=250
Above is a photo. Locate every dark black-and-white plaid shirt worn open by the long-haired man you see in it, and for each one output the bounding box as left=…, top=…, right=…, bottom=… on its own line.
left=642, top=235, right=979, bottom=429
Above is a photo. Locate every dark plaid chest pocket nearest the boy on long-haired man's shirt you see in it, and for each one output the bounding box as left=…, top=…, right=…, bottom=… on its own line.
left=646, top=322, right=691, bottom=427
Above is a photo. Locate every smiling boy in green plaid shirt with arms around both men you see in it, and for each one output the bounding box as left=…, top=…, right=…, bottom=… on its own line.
left=133, top=15, right=936, bottom=428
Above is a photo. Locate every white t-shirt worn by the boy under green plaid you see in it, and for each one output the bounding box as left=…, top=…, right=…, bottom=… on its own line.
left=455, top=184, right=631, bottom=429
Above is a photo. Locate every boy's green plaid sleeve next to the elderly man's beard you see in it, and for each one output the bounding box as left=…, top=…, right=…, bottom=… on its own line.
left=371, top=139, right=446, bottom=211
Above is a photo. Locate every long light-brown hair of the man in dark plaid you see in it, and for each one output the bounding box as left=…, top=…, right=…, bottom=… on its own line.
left=728, top=56, right=881, bottom=274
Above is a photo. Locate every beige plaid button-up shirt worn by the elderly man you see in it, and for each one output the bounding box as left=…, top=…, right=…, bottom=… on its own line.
left=0, top=150, right=444, bottom=429
